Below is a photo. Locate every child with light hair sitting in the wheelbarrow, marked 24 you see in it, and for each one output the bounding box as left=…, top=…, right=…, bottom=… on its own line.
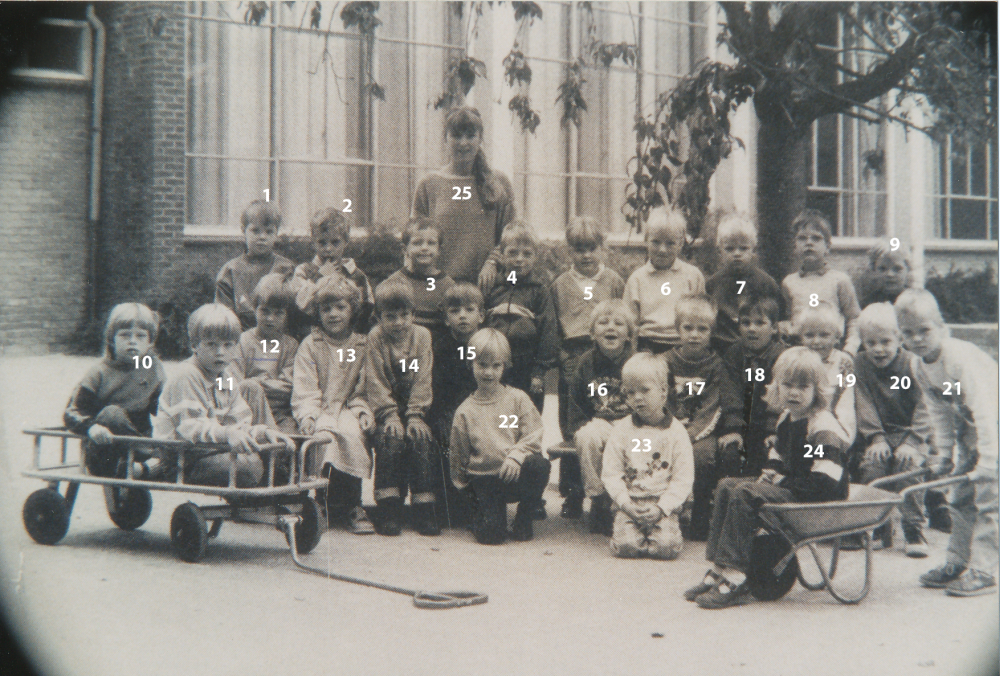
left=684, top=347, right=850, bottom=608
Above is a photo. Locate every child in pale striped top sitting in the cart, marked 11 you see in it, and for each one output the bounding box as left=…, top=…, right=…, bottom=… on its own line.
left=153, top=303, right=295, bottom=488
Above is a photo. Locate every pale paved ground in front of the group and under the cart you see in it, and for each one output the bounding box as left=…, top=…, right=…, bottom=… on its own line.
left=0, top=356, right=998, bottom=676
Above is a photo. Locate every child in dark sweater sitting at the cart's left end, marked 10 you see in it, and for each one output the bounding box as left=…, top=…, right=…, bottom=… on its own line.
left=63, top=303, right=166, bottom=478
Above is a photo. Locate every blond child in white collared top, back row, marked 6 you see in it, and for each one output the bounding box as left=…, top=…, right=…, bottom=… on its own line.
left=625, top=208, right=705, bottom=354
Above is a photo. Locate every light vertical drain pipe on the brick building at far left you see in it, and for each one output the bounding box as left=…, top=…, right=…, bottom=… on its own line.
left=86, top=4, right=106, bottom=326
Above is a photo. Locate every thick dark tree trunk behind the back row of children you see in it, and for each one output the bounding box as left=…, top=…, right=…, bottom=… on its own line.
left=757, top=117, right=809, bottom=283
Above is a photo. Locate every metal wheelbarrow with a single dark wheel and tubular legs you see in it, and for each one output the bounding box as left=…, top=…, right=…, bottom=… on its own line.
left=747, top=469, right=968, bottom=604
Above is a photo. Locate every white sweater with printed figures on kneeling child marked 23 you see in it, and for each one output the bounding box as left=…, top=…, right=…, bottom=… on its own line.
left=601, top=413, right=694, bottom=515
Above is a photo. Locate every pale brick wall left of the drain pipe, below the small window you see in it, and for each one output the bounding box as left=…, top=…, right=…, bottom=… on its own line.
left=0, top=82, right=90, bottom=354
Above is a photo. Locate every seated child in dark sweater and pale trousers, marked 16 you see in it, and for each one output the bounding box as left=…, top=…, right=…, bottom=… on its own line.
left=559, top=300, right=635, bottom=537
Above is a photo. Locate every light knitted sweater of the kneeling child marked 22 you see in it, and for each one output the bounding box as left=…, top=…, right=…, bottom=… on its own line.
left=449, top=385, right=542, bottom=488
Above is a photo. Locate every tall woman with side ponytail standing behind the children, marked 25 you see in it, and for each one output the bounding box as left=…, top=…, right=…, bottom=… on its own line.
left=413, top=107, right=514, bottom=288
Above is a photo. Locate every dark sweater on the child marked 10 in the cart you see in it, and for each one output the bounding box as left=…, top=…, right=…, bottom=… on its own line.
left=63, top=353, right=167, bottom=435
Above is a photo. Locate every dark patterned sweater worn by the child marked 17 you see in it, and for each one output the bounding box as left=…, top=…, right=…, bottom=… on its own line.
left=666, top=347, right=743, bottom=441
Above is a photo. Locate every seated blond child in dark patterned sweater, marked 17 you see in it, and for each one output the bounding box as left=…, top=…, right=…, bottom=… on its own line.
left=666, top=295, right=743, bottom=541
